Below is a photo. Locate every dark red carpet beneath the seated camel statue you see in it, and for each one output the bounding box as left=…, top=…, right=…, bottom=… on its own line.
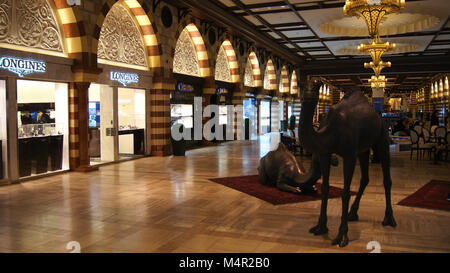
left=209, top=175, right=356, bottom=205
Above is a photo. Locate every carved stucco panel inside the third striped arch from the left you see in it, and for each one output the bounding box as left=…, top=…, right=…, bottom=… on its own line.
left=173, top=29, right=200, bottom=77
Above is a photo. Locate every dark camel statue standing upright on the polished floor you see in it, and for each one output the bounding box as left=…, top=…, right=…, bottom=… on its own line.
left=299, top=82, right=397, bottom=247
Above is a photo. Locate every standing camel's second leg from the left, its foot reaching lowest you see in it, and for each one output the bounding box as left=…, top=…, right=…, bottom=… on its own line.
left=332, top=155, right=356, bottom=247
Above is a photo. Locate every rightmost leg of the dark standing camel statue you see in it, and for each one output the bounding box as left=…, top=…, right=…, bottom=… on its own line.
left=378, top=140, right=397, bottom=227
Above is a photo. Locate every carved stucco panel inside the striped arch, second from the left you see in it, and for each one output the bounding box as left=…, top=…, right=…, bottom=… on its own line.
left=97, top=4, right=148, bottom=67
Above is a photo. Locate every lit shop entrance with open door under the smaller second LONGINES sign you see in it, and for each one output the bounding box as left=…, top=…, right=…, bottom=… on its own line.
left=89, top=84, right=146, bottom=165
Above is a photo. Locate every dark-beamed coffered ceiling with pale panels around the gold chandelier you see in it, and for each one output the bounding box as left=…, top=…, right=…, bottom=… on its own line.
left=170, top=0, right=450, bottom=92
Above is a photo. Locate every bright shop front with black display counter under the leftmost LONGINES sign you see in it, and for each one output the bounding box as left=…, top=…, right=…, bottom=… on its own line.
left=15, top=80, right=69, bottom=177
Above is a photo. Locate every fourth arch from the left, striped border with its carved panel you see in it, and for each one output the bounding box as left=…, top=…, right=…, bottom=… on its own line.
left=215, top=40, right=239, bottom=83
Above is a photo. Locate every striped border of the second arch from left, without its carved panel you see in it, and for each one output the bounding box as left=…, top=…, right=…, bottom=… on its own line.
left=91, top=0, right=162, bottom=71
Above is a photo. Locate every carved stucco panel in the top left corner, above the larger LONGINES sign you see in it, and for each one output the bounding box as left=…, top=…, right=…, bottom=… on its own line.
left=0, top=0, right=63, bottom=53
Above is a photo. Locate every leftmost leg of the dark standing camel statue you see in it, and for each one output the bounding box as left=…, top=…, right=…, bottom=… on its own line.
left=309, top=154, right=331, bottom=235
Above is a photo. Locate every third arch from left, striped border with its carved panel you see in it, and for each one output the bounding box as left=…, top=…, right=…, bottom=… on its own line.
left=173, top=23, right=210, bottom=77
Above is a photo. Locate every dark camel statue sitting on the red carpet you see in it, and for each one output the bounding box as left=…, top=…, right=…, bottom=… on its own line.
left=258, top=142, right=337, bottom=194
